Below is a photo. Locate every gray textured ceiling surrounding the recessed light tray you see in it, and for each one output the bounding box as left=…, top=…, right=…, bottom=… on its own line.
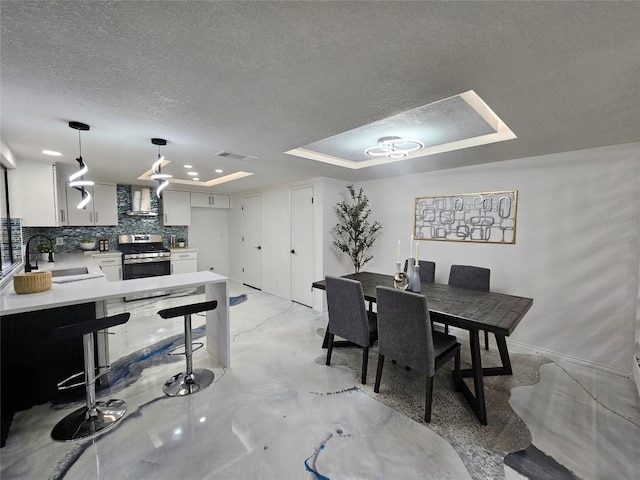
left=0, top=0, right=640, bottom=192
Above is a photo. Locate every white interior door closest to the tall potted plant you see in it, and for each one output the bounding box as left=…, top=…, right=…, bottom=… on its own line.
left=289, top=187, right=315, bottom=307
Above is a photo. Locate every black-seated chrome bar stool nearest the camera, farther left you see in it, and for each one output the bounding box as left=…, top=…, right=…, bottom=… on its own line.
left=51, top=313, right=131, bottom=442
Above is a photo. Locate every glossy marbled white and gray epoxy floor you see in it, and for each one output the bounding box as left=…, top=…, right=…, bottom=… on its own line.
left=0, top=282, right=640, bottom=480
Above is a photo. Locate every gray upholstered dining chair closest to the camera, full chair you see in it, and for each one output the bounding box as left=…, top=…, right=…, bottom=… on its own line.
left=373, top=287, right=462, bottom=423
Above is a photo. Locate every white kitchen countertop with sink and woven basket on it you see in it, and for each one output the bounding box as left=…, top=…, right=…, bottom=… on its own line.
left=0, top=253, right=227, bottom=315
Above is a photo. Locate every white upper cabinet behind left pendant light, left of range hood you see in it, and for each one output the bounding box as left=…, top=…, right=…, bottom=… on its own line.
left=67, top=183, right=118, bottom=226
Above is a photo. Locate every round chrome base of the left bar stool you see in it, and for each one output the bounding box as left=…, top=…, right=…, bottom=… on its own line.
left=51, top=399, right=127, bottom=442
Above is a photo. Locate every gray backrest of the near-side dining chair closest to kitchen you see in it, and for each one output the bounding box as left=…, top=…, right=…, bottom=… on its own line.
left=325, top=275, right=371, bottom=347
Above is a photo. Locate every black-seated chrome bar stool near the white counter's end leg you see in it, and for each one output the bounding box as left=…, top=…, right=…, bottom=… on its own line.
left=158, top=300, right=218, bottom=397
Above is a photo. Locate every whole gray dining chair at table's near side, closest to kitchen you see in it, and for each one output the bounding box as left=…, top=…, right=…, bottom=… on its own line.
left=325, top=275, right=378, bottom=384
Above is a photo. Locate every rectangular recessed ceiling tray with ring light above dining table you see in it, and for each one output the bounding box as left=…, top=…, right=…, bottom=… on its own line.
left=286, top=90, right=516, bottom=169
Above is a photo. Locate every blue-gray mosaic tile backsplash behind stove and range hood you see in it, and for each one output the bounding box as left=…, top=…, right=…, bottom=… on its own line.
left=22, top=185, right=189, bottom=253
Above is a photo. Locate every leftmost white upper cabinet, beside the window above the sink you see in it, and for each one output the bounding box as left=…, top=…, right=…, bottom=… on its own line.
left=9, top=160, right=67, bottom=227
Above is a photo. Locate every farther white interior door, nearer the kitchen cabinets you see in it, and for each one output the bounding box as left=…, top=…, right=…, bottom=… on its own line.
left=242, top=195, right=262, bottom=290
